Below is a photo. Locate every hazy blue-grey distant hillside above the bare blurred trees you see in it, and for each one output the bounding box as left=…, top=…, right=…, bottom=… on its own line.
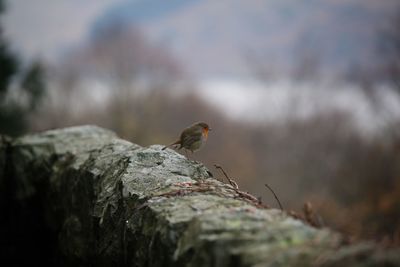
left=92, top=0, right=399, bottom=78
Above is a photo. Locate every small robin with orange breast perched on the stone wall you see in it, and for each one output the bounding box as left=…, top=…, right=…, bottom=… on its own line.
left=162, top=122, right=211, bottom=153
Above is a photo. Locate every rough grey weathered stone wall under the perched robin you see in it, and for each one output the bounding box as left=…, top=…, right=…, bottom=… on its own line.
left=0, top=126, right=400, bottom=266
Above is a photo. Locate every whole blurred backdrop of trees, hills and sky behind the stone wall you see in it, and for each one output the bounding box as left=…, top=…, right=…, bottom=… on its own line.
left=0, top=0, right=400, bottom=244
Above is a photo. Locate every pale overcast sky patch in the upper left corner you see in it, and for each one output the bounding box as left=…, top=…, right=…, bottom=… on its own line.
left=3, top=0, right=125, bottom=59
